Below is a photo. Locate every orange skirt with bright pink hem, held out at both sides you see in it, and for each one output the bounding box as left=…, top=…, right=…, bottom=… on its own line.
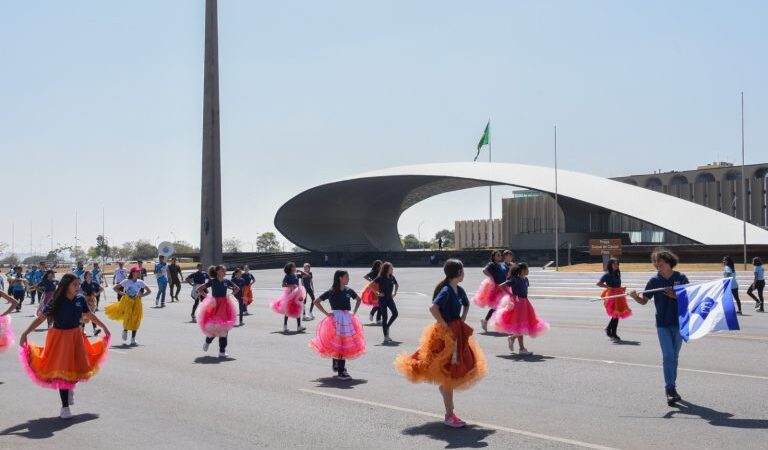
left=19, top=327, right=109, bottom=389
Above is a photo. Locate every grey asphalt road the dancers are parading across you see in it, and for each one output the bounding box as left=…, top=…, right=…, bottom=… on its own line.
left=0, top=268, right=768, bottom=449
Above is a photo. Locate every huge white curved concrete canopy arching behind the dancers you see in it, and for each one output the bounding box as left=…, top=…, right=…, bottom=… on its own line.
left=275, top=162, right=768, bottom=250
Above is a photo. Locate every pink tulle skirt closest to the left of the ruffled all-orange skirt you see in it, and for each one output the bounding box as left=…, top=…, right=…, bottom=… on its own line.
left=309, top=311, right=365, bottom=359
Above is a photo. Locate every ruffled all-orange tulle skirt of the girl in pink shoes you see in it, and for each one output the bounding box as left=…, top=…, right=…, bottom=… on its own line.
left=395, top=320, right=488, bottom=389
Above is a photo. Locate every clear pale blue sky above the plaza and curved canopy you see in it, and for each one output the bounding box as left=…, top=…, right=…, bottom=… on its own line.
left=0, top=0, right=768, bottom=252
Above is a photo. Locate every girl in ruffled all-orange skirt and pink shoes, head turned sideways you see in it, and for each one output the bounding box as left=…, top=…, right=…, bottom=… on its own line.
left=395, top=259, right=488, bottom=428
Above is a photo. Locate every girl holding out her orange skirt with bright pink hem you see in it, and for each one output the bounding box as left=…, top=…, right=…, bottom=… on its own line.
left=19, top=273, right=110, bottom=419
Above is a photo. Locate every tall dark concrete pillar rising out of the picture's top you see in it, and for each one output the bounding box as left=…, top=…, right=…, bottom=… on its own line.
left=200, top=0, right=223, bottom=266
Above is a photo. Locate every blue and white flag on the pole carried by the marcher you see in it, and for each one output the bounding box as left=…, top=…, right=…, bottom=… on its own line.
left=675, top=278, right=739, bottom=342
